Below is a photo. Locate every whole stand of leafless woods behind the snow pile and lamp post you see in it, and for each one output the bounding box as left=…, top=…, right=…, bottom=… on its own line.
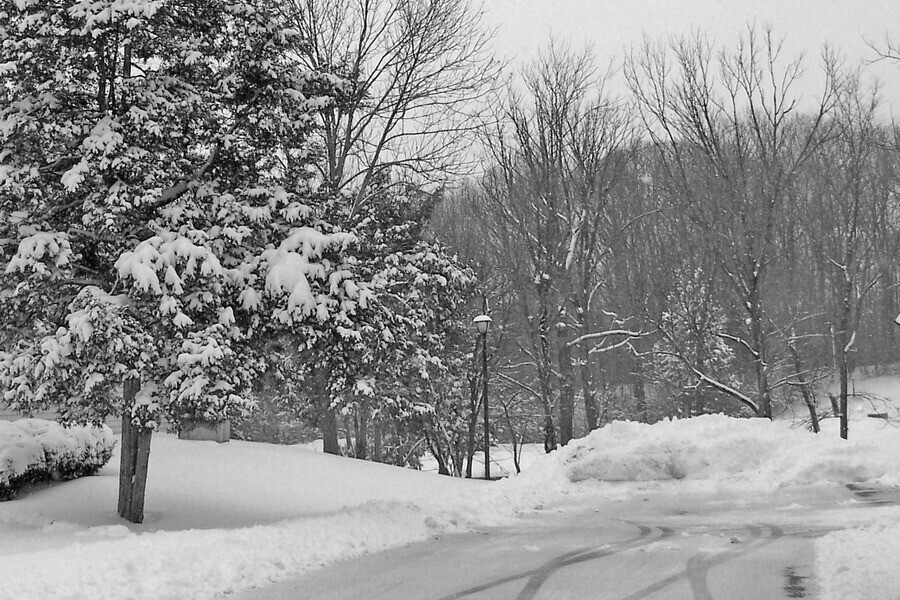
left=434, top=27, right=900, bottom=448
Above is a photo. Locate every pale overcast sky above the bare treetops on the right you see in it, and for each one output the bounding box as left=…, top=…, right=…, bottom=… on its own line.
left=483, top=0, right=900, bottom=113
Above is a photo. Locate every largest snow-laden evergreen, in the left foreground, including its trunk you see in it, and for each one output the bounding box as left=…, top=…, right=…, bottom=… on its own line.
left=0, top=0, right=370, bottom=521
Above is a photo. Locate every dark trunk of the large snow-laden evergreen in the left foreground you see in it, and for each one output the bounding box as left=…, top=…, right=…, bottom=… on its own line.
left=118, top=377, right=153, bottom=523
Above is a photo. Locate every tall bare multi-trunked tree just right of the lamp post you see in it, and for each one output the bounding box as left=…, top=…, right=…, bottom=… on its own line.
left=484, top=44, right=636, bottom=450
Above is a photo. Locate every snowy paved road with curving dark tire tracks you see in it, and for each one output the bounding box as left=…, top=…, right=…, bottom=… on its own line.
left=235, top=488, right=897, bottom=600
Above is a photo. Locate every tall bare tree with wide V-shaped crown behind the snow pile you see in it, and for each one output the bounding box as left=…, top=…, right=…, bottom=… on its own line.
left=625, top=27, right=835, bottom=418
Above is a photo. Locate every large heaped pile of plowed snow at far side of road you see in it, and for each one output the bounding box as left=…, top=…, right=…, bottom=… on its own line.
left=502, top=415, right=900, bottom=490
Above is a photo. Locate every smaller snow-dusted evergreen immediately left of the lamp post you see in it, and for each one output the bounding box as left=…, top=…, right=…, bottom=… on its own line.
left=354, top=188, right=475, bottom=463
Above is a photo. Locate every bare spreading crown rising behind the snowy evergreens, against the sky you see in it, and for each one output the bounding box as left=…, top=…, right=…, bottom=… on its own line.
left=284, top=0, right=502, bottom=215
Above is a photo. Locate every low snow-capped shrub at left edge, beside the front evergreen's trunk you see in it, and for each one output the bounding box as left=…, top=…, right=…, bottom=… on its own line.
left=0, top=419, right=115, bottom=500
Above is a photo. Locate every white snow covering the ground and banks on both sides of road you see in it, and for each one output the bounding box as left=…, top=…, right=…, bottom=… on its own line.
left=0, top=377, right=900, bottom=599
